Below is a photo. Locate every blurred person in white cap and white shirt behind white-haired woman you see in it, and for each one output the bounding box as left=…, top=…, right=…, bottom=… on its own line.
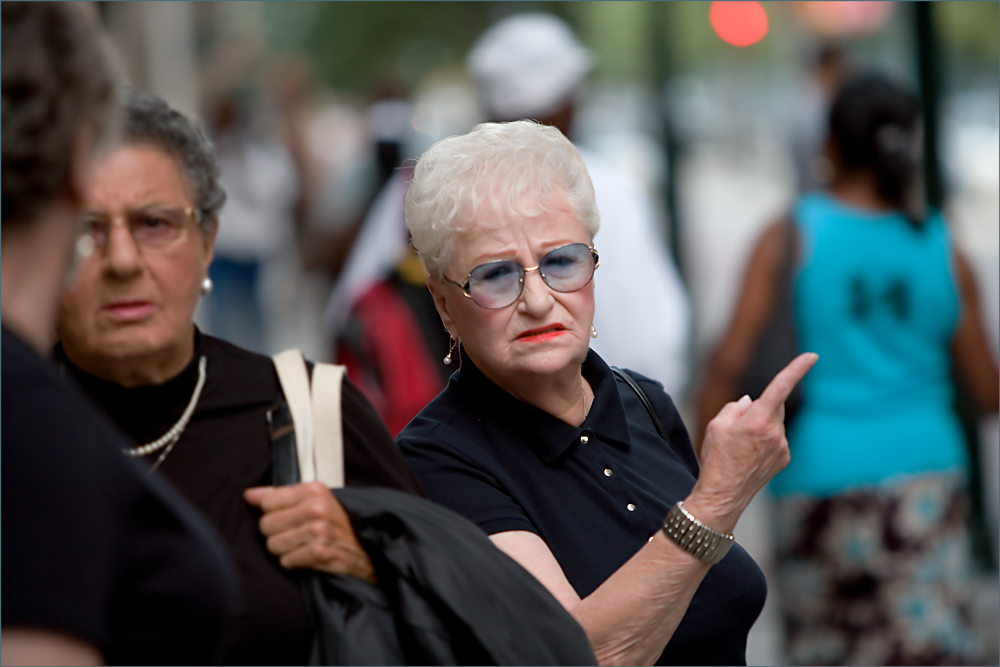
left=466, top=13, right=691, bottom=396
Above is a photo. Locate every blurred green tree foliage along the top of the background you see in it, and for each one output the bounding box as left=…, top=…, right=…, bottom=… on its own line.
left=240, top=0, right=1000, bottom=100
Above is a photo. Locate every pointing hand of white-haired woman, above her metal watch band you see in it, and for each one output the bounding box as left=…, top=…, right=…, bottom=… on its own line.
left=684, top=352, right=818, bottom=533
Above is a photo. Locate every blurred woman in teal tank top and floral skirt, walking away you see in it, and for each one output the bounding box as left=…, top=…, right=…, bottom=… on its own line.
left=699, top=75, right=998, bottom=665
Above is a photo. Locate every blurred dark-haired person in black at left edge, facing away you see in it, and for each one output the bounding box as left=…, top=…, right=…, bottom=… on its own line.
left=0, top=2, right=235, bottom=665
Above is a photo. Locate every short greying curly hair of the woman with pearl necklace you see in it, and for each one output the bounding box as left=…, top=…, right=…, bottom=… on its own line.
left=121, top=86, right=226, bottom=233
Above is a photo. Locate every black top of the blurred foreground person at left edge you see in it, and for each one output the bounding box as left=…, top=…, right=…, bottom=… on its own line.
left=2, top=329, right=236, bottom=665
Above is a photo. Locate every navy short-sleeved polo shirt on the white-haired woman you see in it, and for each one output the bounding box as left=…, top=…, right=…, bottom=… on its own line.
left=398, top=350, right=767, bottom=665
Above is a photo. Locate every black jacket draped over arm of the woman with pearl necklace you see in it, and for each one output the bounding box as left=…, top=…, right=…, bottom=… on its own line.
left=312, top=489, right=596, bottom=665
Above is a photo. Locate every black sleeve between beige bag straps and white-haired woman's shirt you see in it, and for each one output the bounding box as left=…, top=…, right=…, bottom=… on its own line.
left=340, top=375, right=426, bottom=497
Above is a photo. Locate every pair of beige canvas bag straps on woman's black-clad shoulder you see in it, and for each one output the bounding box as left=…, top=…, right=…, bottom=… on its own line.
left=272, top=349, right=346, bottom=488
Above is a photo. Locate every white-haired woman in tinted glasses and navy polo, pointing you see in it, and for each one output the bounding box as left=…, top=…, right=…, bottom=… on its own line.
left=398, top=121, right=816, bottom=664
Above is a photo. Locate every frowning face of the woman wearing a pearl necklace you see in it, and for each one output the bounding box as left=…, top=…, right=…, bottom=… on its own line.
left=58, top=145, right=214, bottom=372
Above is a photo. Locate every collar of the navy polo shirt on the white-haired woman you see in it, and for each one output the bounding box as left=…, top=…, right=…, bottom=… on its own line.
left=452, top=350, right=631, bottom=464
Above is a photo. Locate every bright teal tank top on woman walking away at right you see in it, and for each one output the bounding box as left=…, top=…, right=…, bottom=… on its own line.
left=770, top=193, right=967, bottom=496
